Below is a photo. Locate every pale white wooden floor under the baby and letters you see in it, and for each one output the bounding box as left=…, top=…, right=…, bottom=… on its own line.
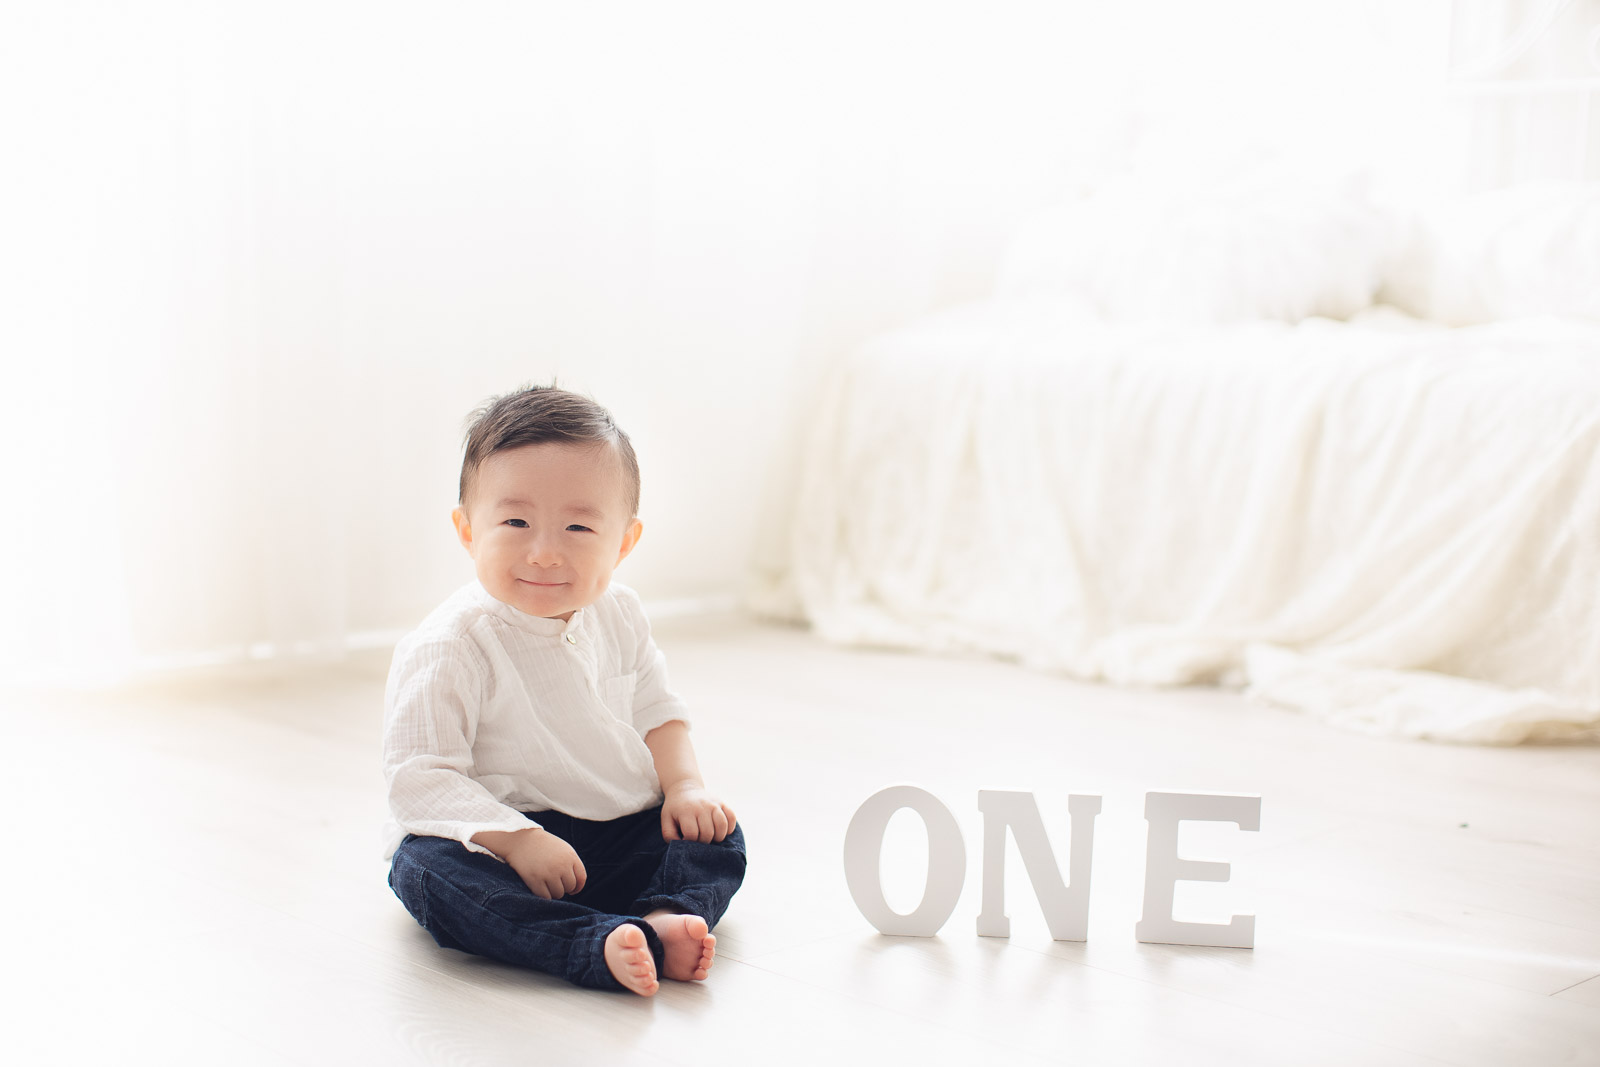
left=0, top=617, right=1600, bottom=1067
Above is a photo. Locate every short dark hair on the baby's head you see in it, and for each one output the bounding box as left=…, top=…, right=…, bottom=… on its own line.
left=461, top=382, right=638, bottom=518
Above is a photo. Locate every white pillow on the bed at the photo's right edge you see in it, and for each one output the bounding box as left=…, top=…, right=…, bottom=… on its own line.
left=1381, top=182, right=1600, bottom=326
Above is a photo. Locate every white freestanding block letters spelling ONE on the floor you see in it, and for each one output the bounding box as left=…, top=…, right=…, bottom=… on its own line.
left=845, top=785, right=1261, bottom=949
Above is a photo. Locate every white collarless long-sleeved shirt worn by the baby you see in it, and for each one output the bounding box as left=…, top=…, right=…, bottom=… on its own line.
left=384, top=581, right=688, bottom=859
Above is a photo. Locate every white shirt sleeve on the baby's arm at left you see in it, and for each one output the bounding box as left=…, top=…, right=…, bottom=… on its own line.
left=384, top=638, right=538, bottom=856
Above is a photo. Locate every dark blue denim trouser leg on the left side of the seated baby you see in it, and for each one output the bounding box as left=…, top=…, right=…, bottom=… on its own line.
left=389, top=835, right=664, bottom=990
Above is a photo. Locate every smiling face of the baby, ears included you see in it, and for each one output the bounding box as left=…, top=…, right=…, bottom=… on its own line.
left=451, top=443, right=643, bottom=619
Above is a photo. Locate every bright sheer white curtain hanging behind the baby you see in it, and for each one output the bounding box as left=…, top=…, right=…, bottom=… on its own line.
left=0, top=0, right=1442, bottom=680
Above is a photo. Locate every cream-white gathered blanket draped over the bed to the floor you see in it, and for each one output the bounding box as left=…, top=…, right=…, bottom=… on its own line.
left=792, top=301, right=1600, bottom=744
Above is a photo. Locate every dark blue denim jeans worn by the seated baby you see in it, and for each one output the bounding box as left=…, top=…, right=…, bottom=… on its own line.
left=389, top=808, right=744, bottom=990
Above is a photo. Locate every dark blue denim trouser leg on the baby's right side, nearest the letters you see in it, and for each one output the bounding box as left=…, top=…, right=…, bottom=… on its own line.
left=584, top=808, right=746, bottom=926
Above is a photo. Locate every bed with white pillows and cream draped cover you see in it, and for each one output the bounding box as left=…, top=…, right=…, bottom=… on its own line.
left=758, top=173, right=1600, bottom=744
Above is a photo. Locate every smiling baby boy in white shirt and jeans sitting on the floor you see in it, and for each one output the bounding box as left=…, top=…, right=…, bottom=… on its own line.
left=384, top=387, right=744, bottom=997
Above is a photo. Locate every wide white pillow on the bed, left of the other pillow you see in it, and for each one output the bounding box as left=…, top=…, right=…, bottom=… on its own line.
left=997, top=166, right=1394, bottom=325
